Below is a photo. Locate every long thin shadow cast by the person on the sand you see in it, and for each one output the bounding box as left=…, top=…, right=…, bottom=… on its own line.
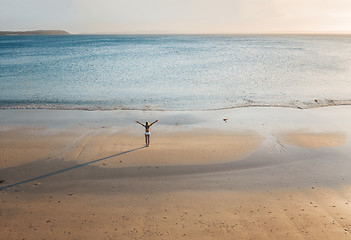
left=0, top=146, right=146, bottom=191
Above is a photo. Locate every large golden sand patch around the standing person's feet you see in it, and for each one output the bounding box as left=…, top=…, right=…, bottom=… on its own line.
left=0, top=127, right=263, bottom=168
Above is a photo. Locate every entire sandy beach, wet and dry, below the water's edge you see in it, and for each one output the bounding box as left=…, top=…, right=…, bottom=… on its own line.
left=0, top=106, right=351, bottom=239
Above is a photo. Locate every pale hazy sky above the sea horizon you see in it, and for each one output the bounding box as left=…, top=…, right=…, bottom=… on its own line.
left=0, top=0, right=351, bottom=34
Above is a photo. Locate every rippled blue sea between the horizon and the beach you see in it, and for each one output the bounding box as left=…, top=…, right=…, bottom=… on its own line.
left=0, top=35, right=351, bottom=110
